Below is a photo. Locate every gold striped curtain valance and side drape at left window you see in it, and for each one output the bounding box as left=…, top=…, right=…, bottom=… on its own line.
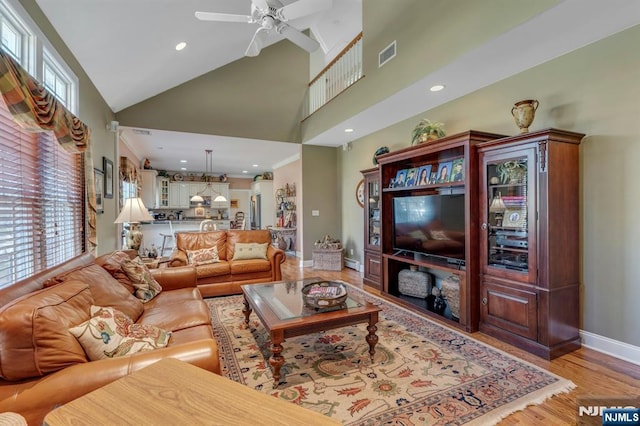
left=0, top=49, right=98, bottom=251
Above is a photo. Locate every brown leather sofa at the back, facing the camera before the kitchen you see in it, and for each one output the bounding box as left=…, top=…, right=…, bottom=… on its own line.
left=169, top=229, right=286, bottom=297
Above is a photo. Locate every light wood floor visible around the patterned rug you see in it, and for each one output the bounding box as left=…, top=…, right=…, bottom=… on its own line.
left=282, top=256, right=640, bottom=425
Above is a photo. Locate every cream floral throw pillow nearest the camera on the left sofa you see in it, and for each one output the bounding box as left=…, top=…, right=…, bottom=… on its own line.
left=69, top=305, right=171, bottom=361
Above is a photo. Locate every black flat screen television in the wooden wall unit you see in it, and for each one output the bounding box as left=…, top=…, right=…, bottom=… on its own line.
left=393, top=194, right=465, bottom=263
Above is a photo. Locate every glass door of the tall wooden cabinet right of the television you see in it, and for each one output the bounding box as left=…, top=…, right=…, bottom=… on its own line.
left=485, top=156, right=535, bottom=273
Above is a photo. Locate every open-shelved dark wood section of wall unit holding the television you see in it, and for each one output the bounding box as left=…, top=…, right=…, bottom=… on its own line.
left=378, top=131, right=503, bottom=331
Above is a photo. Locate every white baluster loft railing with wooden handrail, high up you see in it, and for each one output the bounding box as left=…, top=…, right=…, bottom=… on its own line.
left=304, top=33, right=362, bottom=118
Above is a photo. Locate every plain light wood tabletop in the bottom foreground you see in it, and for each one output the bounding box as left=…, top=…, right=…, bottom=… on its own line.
left=44, top=358, right=340, bottom=426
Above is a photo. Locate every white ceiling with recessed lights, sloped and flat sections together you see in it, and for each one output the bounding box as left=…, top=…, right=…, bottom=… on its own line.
left=36, top=0, right=640, bottom=175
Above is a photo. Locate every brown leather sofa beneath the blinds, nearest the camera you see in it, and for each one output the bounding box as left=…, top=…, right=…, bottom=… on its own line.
left=0, top=253, right=220, bottom=424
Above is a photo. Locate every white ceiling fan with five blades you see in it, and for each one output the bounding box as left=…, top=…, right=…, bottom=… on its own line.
left=196, top=0, right=333, bottom=56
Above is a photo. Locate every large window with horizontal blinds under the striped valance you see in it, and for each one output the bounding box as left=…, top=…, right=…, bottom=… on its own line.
left=0, top=100, right=85, bottom=288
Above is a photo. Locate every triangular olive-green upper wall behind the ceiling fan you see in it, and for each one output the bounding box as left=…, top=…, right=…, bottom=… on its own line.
left=116, top=40, right=309, bottom=142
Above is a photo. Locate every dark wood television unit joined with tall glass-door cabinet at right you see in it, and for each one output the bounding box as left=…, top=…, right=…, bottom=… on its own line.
left=372, top=129, right=584, bottom=359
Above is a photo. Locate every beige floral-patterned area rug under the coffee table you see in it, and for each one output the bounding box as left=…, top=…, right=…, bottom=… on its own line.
left=206, top=286, right=575, bottom=425
